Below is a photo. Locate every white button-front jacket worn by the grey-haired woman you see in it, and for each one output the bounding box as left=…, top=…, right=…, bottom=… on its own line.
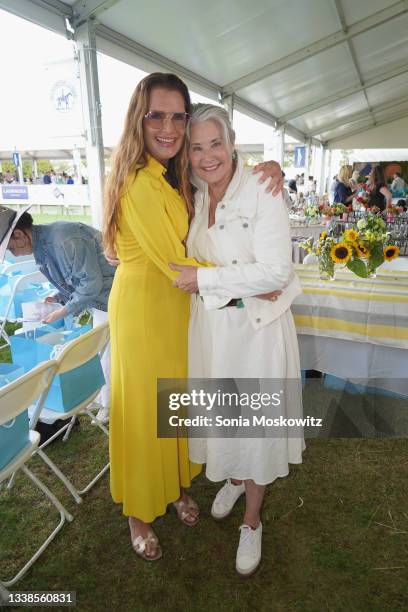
left=187, top=158, right=301, bottom=329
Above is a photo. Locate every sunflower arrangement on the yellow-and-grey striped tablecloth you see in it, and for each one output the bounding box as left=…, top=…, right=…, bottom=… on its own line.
left=300, top=214, right=399, bottom=280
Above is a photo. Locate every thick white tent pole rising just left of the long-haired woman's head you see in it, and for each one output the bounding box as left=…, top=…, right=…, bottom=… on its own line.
left=75, top=20, right=105, bottom=229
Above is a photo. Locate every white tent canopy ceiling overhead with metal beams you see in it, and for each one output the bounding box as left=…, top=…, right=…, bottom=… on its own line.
left=0, top=0, right=408, bottom=148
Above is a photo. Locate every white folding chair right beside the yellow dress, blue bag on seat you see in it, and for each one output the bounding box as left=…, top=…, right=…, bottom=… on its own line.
left=30, top=322, right=110, bottom=504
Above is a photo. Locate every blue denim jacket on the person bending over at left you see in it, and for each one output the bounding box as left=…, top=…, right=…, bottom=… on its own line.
left=32, top=221, right=115, bottom=315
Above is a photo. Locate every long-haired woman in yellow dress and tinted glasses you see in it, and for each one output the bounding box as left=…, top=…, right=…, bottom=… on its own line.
left=104, top=73, right=281, bottom=561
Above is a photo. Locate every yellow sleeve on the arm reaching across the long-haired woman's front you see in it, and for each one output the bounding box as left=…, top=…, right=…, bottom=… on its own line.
left=122, top=176, right=208, bottom=280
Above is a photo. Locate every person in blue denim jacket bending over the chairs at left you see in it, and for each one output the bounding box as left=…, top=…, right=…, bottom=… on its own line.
left=0, top=206, right=115, bottom=422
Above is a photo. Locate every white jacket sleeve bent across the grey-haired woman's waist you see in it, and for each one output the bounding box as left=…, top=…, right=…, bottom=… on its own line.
left=198, top=190, right=293, bottom=298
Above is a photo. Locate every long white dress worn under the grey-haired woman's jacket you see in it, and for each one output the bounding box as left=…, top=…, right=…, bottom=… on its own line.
left=187, top=164, right=305, bottom=485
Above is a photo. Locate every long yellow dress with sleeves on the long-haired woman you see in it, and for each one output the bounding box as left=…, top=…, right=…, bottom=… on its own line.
left=109, top=157, right=201, bottom=522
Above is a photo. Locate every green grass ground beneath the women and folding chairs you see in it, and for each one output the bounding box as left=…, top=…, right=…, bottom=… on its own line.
left=0, top=346, right=408, bottom=612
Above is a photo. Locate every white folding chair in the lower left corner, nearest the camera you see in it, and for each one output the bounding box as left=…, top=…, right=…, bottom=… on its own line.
left=0, top=361, right=72, bottom=597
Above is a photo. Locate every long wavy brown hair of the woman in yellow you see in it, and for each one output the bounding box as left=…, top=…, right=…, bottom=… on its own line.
left=103, top=72, right=194, bottom=256
